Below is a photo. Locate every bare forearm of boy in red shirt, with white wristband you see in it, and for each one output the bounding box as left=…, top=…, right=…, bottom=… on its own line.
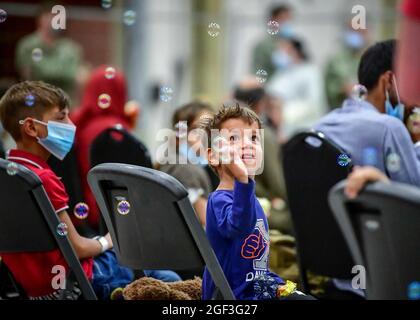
left=59, top=210, right=113, bottom=259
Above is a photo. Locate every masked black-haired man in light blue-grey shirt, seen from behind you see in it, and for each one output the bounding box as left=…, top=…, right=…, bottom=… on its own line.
left=314, top=40, right=420, bottom=186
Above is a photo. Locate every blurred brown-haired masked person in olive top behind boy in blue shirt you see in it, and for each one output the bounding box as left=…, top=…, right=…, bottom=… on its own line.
left=159, top=101, right=212, bottom=226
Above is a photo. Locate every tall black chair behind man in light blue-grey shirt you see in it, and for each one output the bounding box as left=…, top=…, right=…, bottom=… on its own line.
left=283, top=132, right=354, bottom=293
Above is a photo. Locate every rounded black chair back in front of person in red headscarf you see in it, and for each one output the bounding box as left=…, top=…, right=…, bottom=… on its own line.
left=89, top=125, right=153, bottom=168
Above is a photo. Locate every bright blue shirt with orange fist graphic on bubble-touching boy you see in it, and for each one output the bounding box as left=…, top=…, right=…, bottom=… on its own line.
left=202, top=179, right=284, bottom=300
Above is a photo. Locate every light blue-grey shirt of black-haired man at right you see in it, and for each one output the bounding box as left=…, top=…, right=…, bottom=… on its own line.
left=314, top=99, right=420, bottom=187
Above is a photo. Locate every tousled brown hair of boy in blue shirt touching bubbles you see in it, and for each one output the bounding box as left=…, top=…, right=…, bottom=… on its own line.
left=200, top=102, right=262, bottom=152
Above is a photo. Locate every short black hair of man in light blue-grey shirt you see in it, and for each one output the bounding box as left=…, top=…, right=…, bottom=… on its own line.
left=358, top=40, right=396, bottom=90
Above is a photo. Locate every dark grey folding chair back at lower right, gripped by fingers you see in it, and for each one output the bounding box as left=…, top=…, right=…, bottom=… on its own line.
left=329, top=181, right=420, bottom=299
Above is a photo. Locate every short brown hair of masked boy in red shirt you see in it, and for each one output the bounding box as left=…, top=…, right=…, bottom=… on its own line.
left=0, top=81, right=70, bottom=141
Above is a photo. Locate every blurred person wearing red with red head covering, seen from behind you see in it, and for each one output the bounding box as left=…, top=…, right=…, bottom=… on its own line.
left=70, top=66, right=181, bottom=282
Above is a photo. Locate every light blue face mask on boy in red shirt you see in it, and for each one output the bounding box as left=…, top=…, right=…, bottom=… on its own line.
left=20, top=119, right=76, bottom=160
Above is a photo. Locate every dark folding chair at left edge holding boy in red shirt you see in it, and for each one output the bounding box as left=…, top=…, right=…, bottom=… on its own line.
left=0, top=159, right=96, bottom=300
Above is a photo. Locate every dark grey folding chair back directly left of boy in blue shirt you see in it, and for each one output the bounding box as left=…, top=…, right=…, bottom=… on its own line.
left=88, top=163, right=234, bottom=299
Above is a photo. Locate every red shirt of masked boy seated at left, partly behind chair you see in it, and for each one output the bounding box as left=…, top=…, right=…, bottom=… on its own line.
left=2, top=150, right=93, bottom=297
